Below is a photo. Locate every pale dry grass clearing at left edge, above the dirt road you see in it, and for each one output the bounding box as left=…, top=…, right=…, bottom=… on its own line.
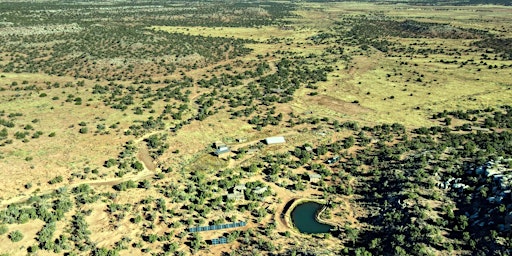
left=0, top=85, right=128, bottom=198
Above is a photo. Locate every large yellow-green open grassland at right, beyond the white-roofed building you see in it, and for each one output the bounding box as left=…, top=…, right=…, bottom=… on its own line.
left=291, top=39, right=512, bottom=127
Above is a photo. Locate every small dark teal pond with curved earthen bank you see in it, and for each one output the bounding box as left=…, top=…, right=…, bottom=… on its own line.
left=291, top=202, right=333, bottom=234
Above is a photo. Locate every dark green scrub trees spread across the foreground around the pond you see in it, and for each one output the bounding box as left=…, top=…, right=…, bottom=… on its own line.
left=0, top=106, right=512, bottom=255
